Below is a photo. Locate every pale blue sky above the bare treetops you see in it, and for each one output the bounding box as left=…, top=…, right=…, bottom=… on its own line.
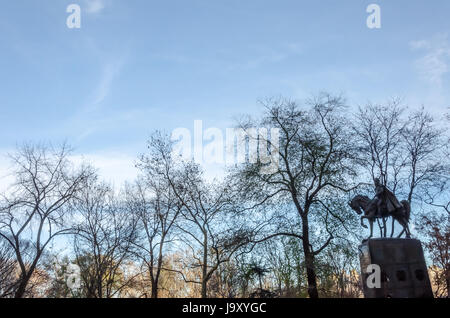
left=0, top=0, right=450, bottom=182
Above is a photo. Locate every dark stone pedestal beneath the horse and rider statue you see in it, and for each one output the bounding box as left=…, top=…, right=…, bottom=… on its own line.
left=358, top=238, right=433, bottom=298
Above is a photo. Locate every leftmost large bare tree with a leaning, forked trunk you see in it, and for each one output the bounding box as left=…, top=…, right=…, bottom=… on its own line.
left=0, top=144, right=91, bottom=298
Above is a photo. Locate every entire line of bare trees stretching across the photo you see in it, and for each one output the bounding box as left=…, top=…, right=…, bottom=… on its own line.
left=0, top=93, right=450, bottom=298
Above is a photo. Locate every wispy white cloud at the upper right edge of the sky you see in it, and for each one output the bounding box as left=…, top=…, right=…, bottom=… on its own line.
left=409, top=34, right=450, bottom=88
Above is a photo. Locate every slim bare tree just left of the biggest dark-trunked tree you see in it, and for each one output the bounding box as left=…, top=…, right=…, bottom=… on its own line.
left=175, top=165, right=248, bottom=298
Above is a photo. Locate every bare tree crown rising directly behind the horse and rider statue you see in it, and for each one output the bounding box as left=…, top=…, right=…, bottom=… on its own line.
left=353, top=99, right=450, bottom=236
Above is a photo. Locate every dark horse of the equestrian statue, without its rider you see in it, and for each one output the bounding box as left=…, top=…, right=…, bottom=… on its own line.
left=349, top=195, right=411, bottom=239
